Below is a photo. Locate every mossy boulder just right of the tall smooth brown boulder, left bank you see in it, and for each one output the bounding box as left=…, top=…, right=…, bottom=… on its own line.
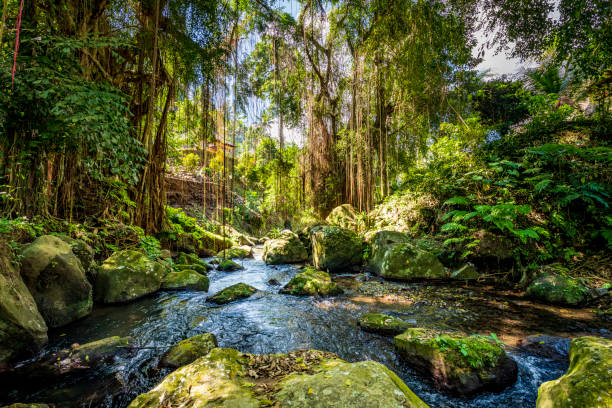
left=95, top=249, right=165, bottom=303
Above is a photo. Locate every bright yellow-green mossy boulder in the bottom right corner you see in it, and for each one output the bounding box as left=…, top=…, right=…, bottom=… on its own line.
left=536, top=337, right=612, bottom=408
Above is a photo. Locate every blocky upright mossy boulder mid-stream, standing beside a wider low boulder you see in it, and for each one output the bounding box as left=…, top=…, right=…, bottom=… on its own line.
left=311, top=226, right=363, bottom=272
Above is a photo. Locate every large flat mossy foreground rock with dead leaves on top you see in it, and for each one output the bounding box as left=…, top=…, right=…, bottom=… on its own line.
left=129, top=348, right=427, bottom=408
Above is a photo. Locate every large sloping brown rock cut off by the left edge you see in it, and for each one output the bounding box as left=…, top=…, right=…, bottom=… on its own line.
left=0, top=243, right=47, bottom=371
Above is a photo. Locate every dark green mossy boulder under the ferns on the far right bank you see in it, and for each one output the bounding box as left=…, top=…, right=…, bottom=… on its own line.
left=527, top=271, right=589, bottom=306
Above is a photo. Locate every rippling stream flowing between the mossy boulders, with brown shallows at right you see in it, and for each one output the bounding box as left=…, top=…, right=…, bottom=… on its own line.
left=0, top=252, right=611, bottom=408
